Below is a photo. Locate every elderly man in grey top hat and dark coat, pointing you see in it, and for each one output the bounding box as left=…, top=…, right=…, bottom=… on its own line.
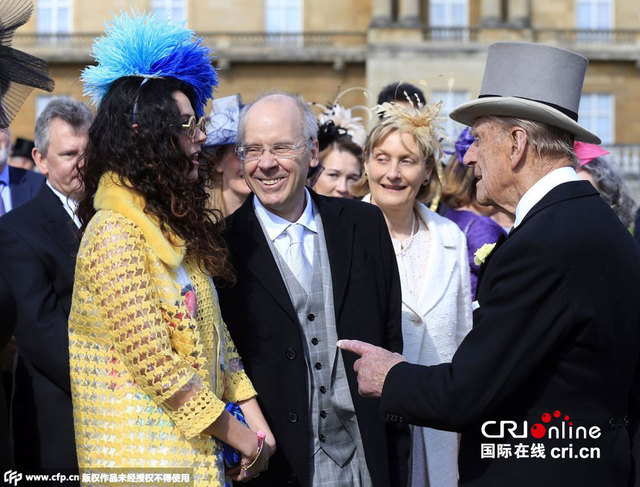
left=339, top=43, right=640, bottom=487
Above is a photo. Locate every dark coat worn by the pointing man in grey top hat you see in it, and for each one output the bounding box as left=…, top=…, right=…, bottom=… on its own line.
left=382, top=181, right=640, bottom=487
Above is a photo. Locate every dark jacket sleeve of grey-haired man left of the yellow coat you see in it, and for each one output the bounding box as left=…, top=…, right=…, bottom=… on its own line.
left=0, top=214, right=71, bottom=394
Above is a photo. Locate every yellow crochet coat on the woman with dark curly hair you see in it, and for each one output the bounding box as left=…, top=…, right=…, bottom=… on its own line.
left=69, top=174, right=256, bottom=486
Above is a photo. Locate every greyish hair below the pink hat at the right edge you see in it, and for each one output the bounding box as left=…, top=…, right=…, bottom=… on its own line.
left=581, top=157, right=636, bottom=227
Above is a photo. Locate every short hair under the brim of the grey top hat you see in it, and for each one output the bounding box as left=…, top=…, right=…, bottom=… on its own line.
left=484, top=115, right=578, bottom=168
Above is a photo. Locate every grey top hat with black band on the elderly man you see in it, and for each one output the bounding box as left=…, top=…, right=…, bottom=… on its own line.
left=449, top=42, right=600, bottom=144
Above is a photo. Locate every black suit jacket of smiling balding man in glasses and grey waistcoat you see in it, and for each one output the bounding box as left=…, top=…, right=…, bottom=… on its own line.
left=220, top=193, right=408, bottom=486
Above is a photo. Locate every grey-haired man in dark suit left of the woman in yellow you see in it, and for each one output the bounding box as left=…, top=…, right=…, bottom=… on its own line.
left=0, top=99, right=92, bottom=472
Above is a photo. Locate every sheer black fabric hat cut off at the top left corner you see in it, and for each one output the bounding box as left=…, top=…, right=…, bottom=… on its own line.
left=0, top=0, right=54, bottom=128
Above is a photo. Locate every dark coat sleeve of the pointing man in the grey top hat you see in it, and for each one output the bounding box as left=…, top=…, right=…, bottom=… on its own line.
left=381, top=239, right=576, bottom=431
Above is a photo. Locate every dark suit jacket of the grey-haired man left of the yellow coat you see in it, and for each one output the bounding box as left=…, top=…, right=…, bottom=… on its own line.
left=0, top=185, right=78, bottom=473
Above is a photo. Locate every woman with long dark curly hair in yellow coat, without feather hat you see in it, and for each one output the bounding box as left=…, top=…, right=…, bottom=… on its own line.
left=69, top=12, right=275, bottom=486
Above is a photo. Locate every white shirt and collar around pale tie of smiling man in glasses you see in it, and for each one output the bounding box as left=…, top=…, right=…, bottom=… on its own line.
left=253, top=188, right=318, bottom=275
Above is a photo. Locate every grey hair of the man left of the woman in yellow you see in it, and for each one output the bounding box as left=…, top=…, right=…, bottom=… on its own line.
left=33, top=98, right=93, bottom=154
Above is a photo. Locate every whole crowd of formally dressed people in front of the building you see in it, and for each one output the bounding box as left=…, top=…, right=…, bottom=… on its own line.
left=0, top=0, right=640, bottom=487
